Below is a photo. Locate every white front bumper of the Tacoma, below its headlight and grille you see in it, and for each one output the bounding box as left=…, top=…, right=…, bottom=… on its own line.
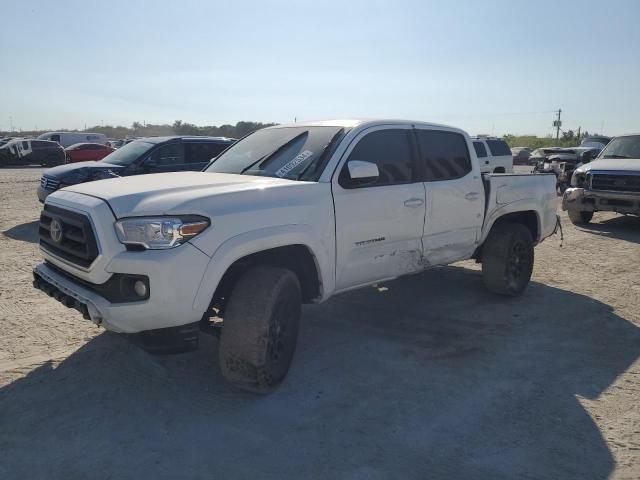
left=33, top=243, right=209, bottom=333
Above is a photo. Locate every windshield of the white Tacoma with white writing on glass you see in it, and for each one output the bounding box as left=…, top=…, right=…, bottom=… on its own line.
left=205, top=126, right=344, bottom=181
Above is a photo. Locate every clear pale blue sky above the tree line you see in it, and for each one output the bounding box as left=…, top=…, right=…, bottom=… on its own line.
left=0, top=0, right=640, bottom=135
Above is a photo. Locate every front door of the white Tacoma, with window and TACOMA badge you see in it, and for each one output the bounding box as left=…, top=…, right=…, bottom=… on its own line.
left=332, top=125, right=425, bottom=290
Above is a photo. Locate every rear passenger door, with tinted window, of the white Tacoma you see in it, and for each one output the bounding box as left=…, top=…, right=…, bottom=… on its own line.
left=416, top=127, right=484, bottom=265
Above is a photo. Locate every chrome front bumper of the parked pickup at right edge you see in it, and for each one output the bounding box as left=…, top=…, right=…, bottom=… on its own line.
left=562, top=187, right=640, bottom=215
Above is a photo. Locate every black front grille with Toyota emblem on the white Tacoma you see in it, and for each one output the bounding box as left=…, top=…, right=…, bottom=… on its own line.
left=39, top=204, right=98, bottom=268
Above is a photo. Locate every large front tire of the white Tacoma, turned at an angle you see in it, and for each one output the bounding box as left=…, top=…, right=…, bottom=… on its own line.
left=218, top=266, right=302, bottom=393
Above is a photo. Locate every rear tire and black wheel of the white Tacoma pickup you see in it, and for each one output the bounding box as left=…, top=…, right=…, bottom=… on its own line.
left=482, top=223, right=534, bottom=296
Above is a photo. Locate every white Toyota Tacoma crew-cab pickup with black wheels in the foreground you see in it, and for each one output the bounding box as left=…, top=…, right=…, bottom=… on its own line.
left=34, top=120, right=557, bottom=392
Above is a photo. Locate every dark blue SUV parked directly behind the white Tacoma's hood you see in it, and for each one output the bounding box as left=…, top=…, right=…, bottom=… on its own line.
left=38, top=136, right=234, bottom=202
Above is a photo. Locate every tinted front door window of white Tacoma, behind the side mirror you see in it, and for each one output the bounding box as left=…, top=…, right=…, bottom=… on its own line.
left=338, top=129, right=413, bottom=187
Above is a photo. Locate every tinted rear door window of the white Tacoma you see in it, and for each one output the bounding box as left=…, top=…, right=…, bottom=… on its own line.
left=416, top=130, right=471, bottom=182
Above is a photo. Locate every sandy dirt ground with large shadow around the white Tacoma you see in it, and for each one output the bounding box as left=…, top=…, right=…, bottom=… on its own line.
left=0, top=168, right=640, bottom=480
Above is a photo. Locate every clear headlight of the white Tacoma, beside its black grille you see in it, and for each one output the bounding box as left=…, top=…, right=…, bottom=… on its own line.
left=115, top=215, right=209, bottom=250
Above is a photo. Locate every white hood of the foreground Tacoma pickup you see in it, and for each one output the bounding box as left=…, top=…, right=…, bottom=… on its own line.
left=61, top=172, right=306, bottom=218
